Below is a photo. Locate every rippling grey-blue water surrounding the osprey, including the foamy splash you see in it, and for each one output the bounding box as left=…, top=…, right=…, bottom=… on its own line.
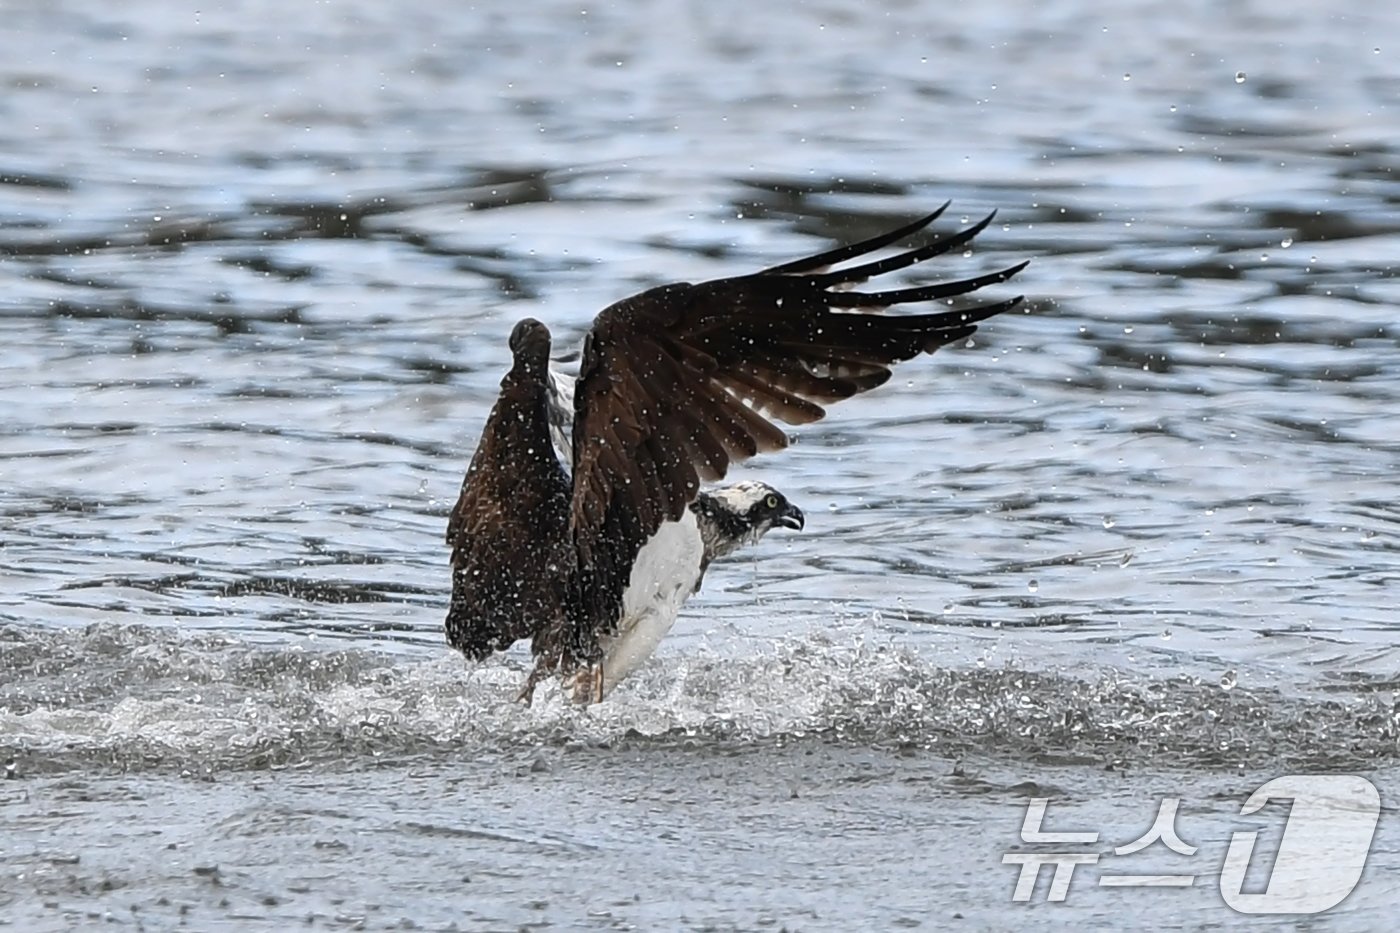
left=0, top=0, right=1400, bottom=930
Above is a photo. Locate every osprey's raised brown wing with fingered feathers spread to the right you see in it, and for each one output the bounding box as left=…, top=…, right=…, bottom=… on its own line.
left=568, top=205, right=1026, bottom=650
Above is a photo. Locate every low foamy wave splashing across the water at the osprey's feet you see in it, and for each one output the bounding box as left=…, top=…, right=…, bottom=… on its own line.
left=0, top=625, right=1400, bottom=775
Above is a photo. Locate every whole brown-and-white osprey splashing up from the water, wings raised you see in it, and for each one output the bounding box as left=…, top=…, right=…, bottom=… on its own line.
left=447, top=205, right=1026, bottom=703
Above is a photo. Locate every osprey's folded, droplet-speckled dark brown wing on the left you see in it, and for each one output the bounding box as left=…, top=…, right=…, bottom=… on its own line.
left=447, top=353, right=574, bottom=660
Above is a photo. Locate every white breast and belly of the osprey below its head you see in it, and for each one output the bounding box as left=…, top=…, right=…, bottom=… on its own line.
left=590, top=509, right=704, bottom=696
